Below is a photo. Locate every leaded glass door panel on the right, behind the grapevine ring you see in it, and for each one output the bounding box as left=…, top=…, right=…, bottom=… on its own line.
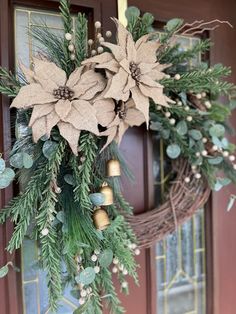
left=153, top=36, right=206, bottom=314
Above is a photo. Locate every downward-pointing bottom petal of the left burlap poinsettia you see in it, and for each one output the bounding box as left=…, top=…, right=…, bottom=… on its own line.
left=58, top=122, right=81, bottom=156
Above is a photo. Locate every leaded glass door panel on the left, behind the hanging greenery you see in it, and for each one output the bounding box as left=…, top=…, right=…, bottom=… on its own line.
left=15, top=8, right=79, bottom=314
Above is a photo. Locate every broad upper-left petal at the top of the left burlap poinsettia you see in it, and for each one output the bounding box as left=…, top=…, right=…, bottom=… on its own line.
left=33, top=58, right=66, bottom=91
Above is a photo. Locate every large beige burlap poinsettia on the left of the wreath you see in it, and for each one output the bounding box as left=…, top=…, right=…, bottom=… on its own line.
left=11, top=59, right=105, bottom=154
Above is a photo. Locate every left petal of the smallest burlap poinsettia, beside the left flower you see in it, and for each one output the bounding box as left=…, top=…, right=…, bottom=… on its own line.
left=93, top=98, right=116, bottom=127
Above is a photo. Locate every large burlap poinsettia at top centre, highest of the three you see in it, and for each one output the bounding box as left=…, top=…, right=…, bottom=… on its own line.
left=83, top=19, right=173, bottom=124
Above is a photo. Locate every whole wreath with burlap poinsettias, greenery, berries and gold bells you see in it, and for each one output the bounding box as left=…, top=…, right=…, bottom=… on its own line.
left=0, top=0, right=236, bottom=314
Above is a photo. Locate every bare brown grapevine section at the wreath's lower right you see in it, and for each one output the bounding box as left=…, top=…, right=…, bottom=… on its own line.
left=126, top=159, right=211, bottom=248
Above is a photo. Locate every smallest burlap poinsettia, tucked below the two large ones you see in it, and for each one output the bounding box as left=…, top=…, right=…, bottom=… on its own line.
left=94, top=99, right=145, bottom=150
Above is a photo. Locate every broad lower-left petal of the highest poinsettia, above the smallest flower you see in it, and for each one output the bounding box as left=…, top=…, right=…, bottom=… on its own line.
left=105, top=68, right=129, bottom=101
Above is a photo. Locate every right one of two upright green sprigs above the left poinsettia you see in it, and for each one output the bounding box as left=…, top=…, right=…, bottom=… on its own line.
left=75, top=13, right=88, bottom=66
